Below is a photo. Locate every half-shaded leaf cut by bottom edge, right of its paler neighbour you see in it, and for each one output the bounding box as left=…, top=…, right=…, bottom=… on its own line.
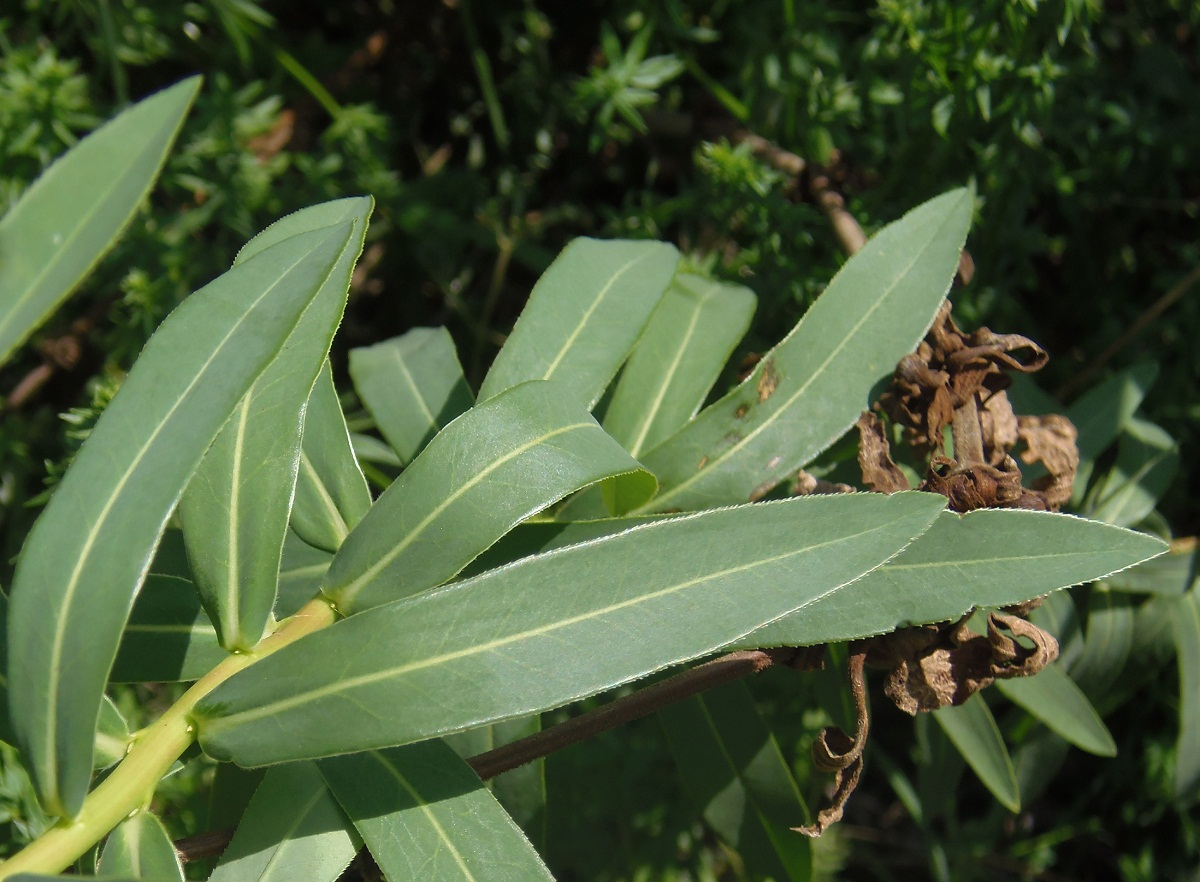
left=319, top=740, right=552, bottom=882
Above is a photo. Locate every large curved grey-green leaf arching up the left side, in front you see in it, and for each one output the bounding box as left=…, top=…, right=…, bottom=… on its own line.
left=8, top=223, right=352, bottom=816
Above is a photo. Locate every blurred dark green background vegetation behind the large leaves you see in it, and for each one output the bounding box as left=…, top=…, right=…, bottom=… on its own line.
left=0, top=0, right=1200, bottom=880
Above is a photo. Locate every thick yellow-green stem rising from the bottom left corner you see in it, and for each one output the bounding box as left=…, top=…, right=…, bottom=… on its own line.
left=0, top=598, right=337, bottom=880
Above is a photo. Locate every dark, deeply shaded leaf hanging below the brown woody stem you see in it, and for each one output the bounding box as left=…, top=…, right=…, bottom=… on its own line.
left=659, top=683, right=812, bottom=882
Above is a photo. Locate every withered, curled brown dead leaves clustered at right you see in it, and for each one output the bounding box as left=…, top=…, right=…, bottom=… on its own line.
left=794, top=302, right=1079, bottom=836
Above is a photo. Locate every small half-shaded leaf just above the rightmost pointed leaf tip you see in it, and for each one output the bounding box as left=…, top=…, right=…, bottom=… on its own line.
left=1087, top=419, right=1180, bottom=527
